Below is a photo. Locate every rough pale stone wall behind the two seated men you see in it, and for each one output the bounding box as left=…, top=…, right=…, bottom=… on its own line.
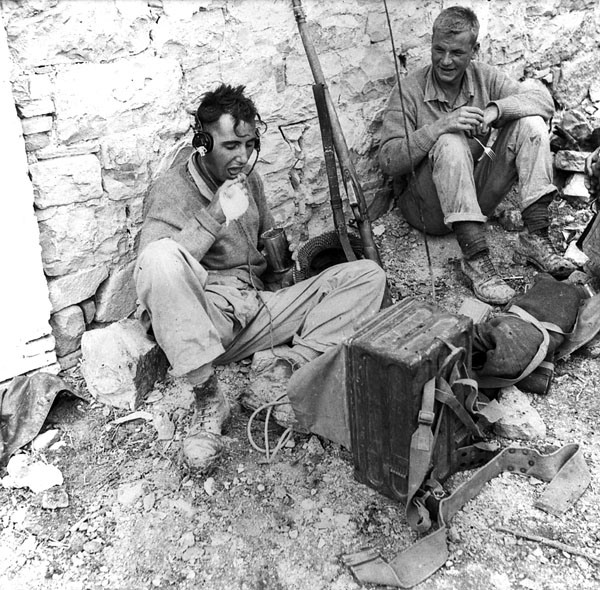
left=0, top=0, right=600, bottom=366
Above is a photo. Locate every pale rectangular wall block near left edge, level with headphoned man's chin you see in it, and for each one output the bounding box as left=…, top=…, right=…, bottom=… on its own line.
left=29, top=154, right=103, bottom=209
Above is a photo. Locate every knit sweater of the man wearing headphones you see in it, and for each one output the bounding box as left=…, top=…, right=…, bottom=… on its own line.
left=139, top=148, right=274, bottom=288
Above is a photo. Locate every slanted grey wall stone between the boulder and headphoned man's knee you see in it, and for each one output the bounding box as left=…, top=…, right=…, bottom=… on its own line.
left=95, top=260, right=137, bottom=323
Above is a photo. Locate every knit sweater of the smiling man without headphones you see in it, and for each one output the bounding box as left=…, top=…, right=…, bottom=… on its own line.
left=379, top=61, right=554, bottom=176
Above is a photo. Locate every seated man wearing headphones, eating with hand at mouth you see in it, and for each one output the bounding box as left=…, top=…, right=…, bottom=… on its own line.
left=135, top=84, right=385, bottom=471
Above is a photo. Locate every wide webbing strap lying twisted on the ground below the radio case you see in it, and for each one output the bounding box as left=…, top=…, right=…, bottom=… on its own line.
left=343, top=444, right=591, bottom=588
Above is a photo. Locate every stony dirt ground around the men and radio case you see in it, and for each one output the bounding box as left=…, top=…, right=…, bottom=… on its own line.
left=0, top=201, right=600, bottom=590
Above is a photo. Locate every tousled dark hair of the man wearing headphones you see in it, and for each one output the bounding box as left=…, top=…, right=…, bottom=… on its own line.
left=196, top=84, right=261, bottom=127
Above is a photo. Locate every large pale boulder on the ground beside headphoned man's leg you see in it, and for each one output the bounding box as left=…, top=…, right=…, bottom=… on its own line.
left=81, top=319, right=168, bottom=410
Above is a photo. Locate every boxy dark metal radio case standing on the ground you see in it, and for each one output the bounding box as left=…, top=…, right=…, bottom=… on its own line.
left=346, top=298, right=472, bottom=504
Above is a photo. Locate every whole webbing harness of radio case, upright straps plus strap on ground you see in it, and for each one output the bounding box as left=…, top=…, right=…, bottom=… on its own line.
left=343, top=368, right=591, bottom=588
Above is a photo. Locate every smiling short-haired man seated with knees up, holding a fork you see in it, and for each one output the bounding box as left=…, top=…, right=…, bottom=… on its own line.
left=379, top=6, right=575, bottom=305
